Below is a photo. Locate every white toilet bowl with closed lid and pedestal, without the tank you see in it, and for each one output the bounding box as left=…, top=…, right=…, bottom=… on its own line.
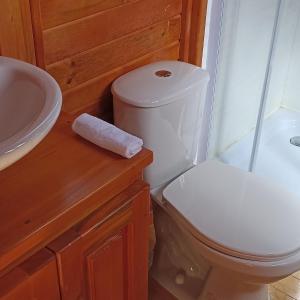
left=163, top=161, right=300, bottom=300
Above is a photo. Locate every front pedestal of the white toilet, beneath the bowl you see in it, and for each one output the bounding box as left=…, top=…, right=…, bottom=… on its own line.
left=199, top=267, right=270, bottom=300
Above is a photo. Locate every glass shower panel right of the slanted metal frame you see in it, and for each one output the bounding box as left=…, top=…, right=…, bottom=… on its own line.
left=252, top=0, right=300, bottom=196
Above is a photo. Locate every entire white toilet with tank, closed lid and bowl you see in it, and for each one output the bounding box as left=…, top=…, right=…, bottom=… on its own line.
left=112, top=61, right=300, bottom=300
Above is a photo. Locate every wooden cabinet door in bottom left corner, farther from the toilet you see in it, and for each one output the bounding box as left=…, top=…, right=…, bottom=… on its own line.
left=0, top=249, right=60, bottom=300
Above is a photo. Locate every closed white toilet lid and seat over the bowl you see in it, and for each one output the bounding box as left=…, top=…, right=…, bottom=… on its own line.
left=163, top=161, right=300, bottom=261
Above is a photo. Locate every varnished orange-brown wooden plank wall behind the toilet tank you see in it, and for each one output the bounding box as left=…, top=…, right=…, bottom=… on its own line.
left=0, top=0, right=207, bottom=119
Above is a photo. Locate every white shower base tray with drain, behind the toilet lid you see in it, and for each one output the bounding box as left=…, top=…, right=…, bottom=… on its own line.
left=219, top=108, right=300, bottom=196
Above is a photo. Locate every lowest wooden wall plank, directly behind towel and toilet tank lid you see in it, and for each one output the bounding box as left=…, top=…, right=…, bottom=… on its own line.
left=63, top=41, right=179, bottom=114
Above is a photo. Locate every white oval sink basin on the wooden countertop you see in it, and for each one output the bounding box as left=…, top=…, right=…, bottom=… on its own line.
left=0, top=56, right=62, bottom=170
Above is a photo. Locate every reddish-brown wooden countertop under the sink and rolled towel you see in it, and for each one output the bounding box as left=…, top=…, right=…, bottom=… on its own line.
left=0, top=115, right=152, bottom=274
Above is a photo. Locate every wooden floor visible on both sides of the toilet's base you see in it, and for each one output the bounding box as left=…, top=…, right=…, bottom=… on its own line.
left=149, top=271, right=300, bottom=300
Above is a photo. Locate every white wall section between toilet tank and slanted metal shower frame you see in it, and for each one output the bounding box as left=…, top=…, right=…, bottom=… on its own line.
left=210, top=0, right=280, bottom=156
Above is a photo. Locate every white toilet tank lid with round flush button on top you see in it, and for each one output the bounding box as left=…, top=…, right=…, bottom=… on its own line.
left=112, top=61, right=209, bottom=107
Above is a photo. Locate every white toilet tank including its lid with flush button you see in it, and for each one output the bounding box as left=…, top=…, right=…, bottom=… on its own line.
left=112, top=61, right=209, bottom=188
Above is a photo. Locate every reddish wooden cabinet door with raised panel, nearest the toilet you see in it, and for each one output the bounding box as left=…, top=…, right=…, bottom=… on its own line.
left=49, top=181, right=149, bottom=300
